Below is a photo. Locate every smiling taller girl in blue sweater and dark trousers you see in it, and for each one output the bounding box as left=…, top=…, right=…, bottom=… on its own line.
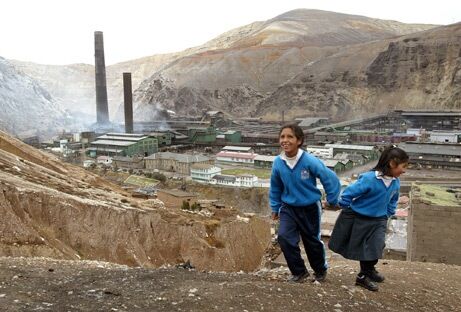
left=269, top=125, right=341, bottom=282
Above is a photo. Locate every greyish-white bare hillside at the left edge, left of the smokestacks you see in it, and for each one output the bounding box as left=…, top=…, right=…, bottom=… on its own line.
left=0, top=57, right=66, bottom=136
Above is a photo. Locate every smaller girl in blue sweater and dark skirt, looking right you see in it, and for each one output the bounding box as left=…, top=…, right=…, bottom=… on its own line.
left=328, top=145, right=408, bottom=291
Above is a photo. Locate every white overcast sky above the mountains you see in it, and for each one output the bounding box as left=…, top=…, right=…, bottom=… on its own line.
left=0, top=0, right=461, bottom=65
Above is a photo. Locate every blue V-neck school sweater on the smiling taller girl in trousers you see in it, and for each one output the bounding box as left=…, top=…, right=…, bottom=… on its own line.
left=269, top=151, right=341, bottom=213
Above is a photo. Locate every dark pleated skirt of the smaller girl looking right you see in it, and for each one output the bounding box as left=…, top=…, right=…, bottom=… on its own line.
left=328, top=208, right=387, bottom=261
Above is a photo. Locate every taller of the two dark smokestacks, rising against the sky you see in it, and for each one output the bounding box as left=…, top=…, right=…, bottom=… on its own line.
left=94, top=31, right=109, bottom=124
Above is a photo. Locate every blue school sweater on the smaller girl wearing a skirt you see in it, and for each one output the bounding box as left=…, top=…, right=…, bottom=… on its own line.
left=339, top=171, right=400, bottom=217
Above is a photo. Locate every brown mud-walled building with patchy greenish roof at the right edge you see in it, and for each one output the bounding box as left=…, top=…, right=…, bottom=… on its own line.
left=407, top=184, right=461, bottom=265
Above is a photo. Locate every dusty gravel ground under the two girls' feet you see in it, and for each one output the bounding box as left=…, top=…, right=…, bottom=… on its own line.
left=0, top=258, right=461, bottom=312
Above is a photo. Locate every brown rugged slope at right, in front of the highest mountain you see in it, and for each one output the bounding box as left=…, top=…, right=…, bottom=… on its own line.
left=255, top=23, right=461, bottom=119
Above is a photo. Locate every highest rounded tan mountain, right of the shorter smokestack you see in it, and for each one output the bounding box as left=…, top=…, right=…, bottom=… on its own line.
left=131, top=9, right=434, bottom=119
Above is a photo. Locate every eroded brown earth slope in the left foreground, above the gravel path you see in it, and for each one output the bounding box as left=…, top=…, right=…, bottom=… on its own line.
left=0, top=132, right=270, bottom=271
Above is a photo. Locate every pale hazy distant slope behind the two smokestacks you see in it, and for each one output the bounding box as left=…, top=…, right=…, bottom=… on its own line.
left=10, top=51, right=181, bottom=123
